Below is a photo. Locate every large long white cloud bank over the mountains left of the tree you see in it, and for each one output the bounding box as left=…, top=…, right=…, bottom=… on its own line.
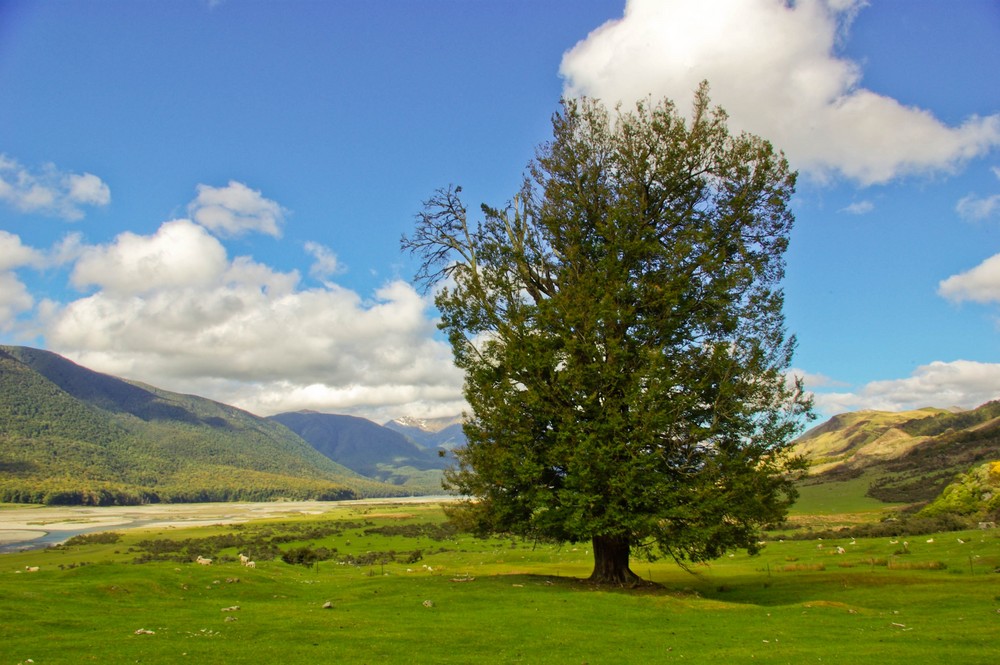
left=45, top=220, right=464, bottom=420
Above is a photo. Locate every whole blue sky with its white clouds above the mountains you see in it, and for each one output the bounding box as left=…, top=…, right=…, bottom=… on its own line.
left=0, top=0, right=1000, bottom=421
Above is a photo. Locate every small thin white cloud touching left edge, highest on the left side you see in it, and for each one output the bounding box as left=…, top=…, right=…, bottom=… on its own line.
left=0, top=154, right=111, bottom=221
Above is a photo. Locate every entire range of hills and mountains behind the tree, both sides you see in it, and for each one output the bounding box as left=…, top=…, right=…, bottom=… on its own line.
left=0, top=346, right=1000, bottom=512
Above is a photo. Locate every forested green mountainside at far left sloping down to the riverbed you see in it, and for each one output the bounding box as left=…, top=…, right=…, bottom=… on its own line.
left=0, top=347, right=399, bottom=504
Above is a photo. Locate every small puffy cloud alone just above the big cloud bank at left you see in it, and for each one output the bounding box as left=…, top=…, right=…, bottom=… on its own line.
left=188, top=180, right=286, bottom=238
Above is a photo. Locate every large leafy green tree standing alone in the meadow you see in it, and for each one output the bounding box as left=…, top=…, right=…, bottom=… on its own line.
left=403, top=84, right=810, bottom=584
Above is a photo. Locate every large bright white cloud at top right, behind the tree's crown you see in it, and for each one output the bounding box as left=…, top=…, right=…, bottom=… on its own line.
left=560, top=0, right=1000, bottom=185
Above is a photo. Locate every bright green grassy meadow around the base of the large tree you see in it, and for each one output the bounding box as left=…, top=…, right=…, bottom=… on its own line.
left=0, top=504, right=1000, bottom=665
